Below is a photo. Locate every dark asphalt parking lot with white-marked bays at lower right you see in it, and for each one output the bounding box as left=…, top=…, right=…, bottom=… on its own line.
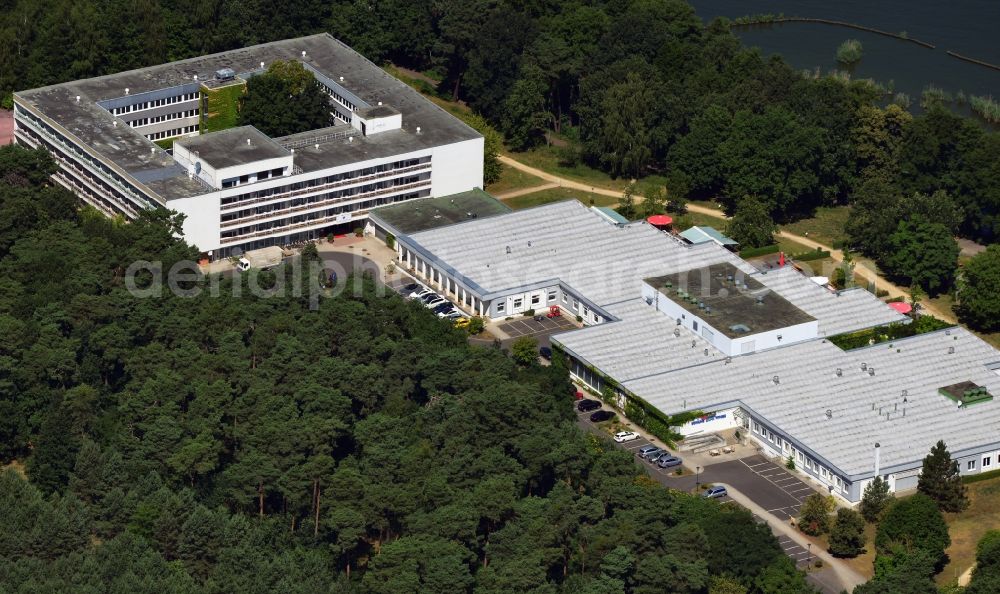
left=574, top=402, right=817, bottom=568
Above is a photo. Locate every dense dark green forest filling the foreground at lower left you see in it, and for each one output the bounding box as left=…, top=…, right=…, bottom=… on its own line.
left=0, top=146, right=808, bottom=594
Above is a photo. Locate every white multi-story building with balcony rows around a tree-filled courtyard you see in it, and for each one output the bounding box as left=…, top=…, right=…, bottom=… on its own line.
left=14, top=34, right=483, bottom=258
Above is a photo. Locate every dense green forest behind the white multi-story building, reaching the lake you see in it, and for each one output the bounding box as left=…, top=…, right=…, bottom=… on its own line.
left=0, top=0, right=1000, bottom=245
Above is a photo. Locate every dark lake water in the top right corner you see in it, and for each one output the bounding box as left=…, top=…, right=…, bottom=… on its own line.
left=689, top=0, right=1000, bottom=111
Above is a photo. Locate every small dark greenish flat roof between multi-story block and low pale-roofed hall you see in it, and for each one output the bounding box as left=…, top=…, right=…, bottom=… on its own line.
left=370, top=188, right=510, bottom=235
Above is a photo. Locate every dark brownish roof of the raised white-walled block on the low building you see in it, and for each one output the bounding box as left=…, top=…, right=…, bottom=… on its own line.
left=646, top=262, right=815, bottom=338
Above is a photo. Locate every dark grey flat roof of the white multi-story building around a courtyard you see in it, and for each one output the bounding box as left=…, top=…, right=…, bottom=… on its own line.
left=14, top=33, right=480, bottom=200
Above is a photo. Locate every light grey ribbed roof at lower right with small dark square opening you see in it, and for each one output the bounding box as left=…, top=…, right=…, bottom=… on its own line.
left=623, top=328, right=1000, bottom=476
